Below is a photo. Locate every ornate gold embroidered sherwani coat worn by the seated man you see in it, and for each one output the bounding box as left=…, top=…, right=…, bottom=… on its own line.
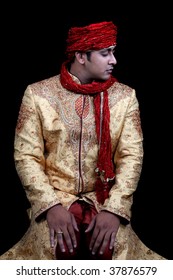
left=1, top=75, right=165, bottom=260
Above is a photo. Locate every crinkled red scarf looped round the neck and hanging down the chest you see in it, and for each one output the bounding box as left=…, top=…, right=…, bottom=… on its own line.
left=60, top=63, right=116, bottom=204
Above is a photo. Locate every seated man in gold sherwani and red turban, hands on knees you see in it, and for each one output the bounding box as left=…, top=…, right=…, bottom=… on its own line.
left=2, top=22, right=165, bottom=260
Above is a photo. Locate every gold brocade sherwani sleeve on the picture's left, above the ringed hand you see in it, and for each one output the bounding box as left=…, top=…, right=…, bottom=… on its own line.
left=14, top=86, right=59, bottom=218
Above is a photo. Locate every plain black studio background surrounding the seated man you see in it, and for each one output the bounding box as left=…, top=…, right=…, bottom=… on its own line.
left=0, top=1, right=173, bottom=259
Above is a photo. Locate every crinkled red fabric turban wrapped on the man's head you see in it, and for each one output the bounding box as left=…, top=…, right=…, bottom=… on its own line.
left=66, top=21, right=117, bottom=58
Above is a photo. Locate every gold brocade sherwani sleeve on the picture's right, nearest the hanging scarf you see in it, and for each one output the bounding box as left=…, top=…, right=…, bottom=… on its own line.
left=103, top=90, right=143, bottom=222
